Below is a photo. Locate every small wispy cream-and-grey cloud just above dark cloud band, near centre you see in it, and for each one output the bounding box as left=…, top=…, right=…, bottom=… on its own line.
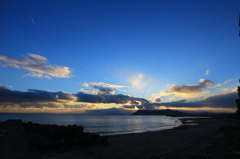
left=80, top=82, right=124, bottom=95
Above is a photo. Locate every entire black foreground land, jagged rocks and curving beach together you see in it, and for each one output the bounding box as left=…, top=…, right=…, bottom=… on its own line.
left=0, top=115, right=240, bottom=159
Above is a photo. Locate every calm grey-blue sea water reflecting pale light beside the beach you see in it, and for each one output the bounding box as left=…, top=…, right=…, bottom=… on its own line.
left=0, top=113, right=181, bottom=135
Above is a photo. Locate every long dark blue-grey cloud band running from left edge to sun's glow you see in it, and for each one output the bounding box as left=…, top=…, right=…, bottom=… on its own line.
left=0, top=86, right=149, bottom=104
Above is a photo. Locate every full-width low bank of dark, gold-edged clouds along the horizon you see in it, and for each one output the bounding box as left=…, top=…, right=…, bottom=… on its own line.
left=0, top=85, right=238, bottom=114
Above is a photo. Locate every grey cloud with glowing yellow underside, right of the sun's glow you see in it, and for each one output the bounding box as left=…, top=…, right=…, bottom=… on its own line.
left=160, top=79, right=218, bottom=97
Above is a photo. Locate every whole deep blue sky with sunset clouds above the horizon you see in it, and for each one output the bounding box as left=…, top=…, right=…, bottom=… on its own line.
left=0, top=0, right=240, bottom=114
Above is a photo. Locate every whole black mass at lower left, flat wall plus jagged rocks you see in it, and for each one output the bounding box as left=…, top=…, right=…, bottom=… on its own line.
left=0, top=120, right=108, bottom=159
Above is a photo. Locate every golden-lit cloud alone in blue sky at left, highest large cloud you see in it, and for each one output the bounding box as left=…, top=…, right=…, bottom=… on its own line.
left=0, top=53, right=71, bottom=79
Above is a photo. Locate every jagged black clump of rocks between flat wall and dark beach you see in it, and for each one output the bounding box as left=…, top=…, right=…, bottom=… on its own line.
left=22, top=122, right=108, bottom=153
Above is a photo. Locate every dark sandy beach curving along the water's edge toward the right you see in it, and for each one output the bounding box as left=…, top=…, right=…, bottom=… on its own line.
left=41, top=116, right=240, bottom=159
